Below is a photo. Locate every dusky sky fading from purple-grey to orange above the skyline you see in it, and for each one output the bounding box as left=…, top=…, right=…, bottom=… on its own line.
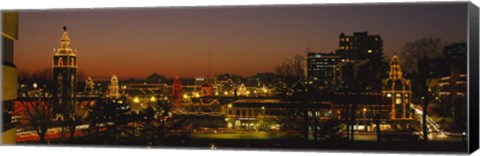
left=15, top=3, right=467, bottom=80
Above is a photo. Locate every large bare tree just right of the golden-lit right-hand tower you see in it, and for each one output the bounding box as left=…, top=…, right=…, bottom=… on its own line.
left=401, top=38, right=445, bottom=141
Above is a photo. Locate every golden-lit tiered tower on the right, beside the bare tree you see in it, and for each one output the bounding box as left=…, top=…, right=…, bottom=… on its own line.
left=382, top=55, right=412, bottom=119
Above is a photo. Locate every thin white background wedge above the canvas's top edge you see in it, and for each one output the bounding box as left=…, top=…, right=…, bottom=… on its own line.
left=0, top=0, right=472, bottom=10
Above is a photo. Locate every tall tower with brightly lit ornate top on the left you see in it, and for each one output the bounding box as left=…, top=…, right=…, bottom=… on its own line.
left=52, top=26, right=77, bottom=116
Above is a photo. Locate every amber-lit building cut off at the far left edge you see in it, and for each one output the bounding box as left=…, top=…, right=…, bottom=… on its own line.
left=0, top=12, right=18, bottom=144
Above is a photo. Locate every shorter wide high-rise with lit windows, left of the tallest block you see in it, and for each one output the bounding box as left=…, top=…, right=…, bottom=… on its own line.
left=305, top=52, right=341, bottom=89
